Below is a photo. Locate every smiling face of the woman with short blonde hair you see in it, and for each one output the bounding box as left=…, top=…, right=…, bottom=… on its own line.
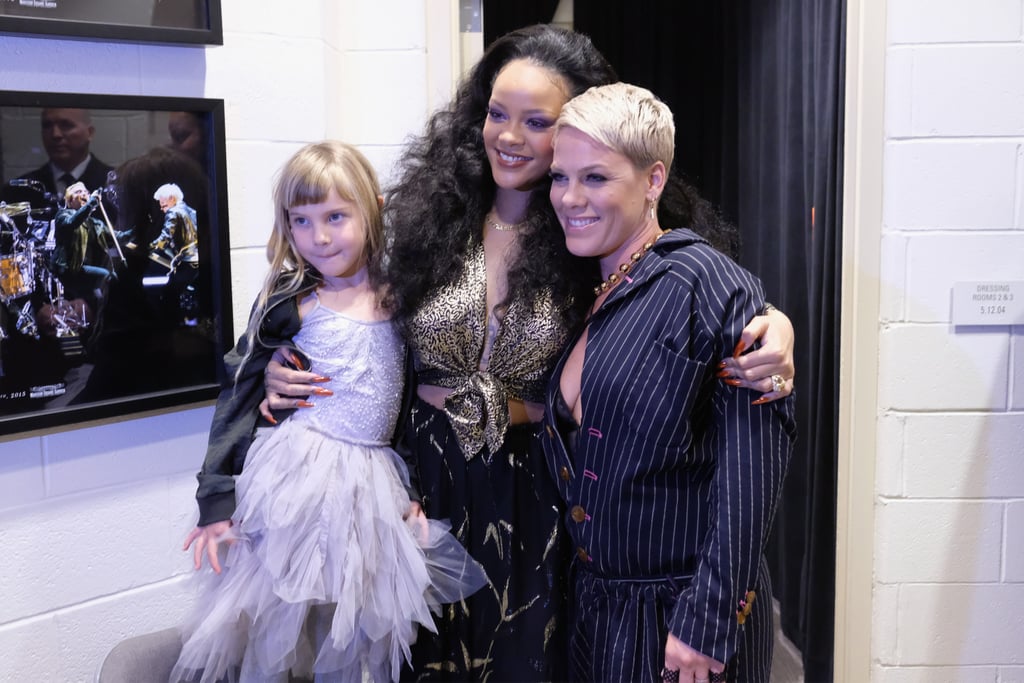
left=551, top=127, right=666, bottom=272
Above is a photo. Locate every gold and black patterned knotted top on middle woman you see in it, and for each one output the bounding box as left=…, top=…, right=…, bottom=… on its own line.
left=410, top=245, right=567, bottom=460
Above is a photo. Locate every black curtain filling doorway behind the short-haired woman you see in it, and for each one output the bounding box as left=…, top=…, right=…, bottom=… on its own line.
left=573, top=0, right=845, bottom=682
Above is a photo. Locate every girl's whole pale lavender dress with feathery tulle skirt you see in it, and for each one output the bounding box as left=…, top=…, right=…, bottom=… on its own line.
left=172, top=302, right=485, bottom=683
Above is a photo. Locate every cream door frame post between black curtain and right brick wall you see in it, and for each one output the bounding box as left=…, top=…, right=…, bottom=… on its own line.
left=834, top=0, right=887, bottom=683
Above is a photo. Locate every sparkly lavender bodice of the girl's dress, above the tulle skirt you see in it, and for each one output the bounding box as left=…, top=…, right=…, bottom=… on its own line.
left=291, top=301, right=406, bottom=445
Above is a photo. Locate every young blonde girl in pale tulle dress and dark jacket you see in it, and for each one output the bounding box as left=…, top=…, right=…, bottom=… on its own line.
left=172, top=141, right=484, bottom=681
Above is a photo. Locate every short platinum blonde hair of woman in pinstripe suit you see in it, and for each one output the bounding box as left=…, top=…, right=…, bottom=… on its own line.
left=554, top=83, right=676, bottom=171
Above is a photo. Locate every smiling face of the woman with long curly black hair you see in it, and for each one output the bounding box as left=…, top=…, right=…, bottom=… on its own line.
left=483, top=59, right=569, bottom=189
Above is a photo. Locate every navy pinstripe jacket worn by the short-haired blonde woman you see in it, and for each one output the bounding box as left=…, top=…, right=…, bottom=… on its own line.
left=542, top=229, right=796, bottom=661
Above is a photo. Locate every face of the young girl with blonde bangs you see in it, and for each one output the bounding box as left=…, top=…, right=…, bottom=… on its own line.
left=288, top=189, right=367, bottom=278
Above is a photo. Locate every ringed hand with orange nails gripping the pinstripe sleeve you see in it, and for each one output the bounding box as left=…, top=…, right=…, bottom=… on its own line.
left=718, top=308, right=796, bottom=405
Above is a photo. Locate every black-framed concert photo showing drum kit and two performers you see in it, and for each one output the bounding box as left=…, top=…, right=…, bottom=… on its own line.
left=0, top=91, right=232, bottom=435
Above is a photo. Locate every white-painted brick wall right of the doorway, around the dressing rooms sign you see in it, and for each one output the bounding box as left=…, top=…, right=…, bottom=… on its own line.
left=872, top=0, right=1024, bottom=683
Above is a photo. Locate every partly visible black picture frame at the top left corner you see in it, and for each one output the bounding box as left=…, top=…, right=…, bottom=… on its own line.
left=0, top=0, right=224, bottom=45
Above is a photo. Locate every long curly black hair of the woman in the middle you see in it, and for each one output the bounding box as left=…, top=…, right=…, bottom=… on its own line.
left=384, top=25, right=728, bottom=329
